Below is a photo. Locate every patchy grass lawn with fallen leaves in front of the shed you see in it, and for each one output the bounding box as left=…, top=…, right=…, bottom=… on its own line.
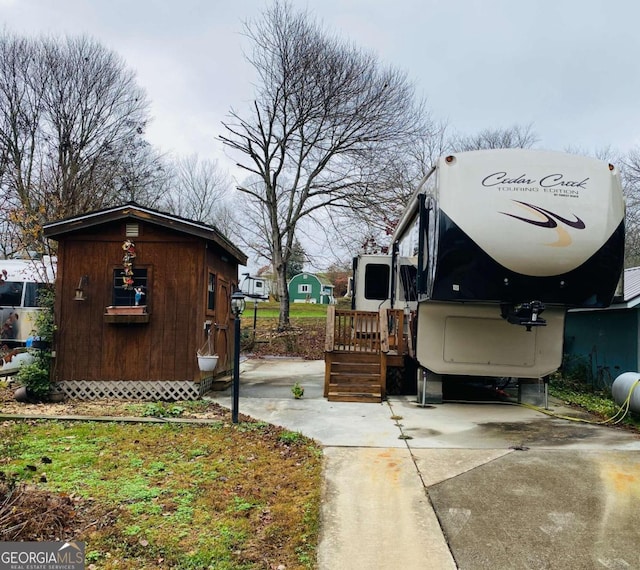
left=0, top=408, right=322, bottom=570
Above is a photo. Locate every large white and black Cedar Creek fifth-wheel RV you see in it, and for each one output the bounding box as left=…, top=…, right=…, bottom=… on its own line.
left=340, top=149, right=624, bottom=402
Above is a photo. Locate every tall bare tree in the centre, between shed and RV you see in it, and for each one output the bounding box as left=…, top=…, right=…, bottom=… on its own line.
left=221, top=1, right=422, bottom=329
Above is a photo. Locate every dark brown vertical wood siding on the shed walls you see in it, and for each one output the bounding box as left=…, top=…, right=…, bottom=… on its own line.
left=54, top=220, right=237, bottom=381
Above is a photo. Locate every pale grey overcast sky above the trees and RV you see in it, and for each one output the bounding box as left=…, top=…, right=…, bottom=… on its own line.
left=0, top=0, right=640, bottom=180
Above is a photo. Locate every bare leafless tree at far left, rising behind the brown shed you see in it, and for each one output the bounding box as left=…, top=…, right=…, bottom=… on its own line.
left=0, top=32, right=151, bottom=258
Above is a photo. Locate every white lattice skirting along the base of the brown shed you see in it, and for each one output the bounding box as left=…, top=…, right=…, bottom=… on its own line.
left=58, top=378, right=213, bottom=400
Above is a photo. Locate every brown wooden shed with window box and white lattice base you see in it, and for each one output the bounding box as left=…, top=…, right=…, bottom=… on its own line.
left=44, top=202, right=247, bottom=400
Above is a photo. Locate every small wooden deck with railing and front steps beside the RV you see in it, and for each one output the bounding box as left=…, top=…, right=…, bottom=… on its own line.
left=324, top=305, right=404, bottom=403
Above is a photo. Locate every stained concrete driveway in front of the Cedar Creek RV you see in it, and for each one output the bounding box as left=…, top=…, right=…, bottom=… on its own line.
left=208, top=359, right=640, bottom=570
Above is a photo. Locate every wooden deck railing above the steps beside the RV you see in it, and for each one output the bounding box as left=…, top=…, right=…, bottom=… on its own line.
left=325, top=305, right=406, bottom=354
